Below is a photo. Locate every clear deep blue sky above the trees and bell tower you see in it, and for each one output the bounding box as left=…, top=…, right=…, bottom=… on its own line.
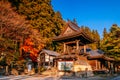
left=51, top=0, right=120, bottom=37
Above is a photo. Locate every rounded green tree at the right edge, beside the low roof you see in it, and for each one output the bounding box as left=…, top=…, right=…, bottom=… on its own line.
left=100, top=24, right=120, bottom=60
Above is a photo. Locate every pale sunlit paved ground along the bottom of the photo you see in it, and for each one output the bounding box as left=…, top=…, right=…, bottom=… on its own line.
left=0, top=75, right=120, bottom=80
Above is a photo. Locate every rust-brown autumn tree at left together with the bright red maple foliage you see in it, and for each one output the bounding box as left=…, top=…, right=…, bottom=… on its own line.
left=0, top=0, right=44, bottom=62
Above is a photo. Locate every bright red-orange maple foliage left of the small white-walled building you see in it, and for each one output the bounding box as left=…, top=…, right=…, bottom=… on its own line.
left=21, top=38, right=39, bottom=62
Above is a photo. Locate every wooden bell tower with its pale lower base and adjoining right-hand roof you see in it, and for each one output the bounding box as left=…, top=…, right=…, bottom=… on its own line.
left=53, top=21, right=112, bottom=75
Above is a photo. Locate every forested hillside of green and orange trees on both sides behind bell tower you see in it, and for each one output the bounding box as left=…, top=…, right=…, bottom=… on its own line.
left=0, top=0, right=120, bottom=69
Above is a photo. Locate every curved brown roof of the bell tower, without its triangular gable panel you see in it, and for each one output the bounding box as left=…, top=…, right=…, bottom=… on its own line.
left=53, top=21, right=95, bottom=43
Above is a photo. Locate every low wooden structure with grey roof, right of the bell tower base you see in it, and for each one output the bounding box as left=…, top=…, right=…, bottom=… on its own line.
left=87, top=50, right=114, bottom=70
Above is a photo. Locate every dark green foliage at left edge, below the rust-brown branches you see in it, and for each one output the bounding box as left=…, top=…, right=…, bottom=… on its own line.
left=0, top=38, right=20, bottom=65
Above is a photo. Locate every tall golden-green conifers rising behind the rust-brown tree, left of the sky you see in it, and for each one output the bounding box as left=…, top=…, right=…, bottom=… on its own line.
left=9, top=0, right=64, bottom=49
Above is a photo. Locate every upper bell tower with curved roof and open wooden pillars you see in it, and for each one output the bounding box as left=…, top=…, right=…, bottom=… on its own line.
left=53, top=21, right=94, bottom=54
